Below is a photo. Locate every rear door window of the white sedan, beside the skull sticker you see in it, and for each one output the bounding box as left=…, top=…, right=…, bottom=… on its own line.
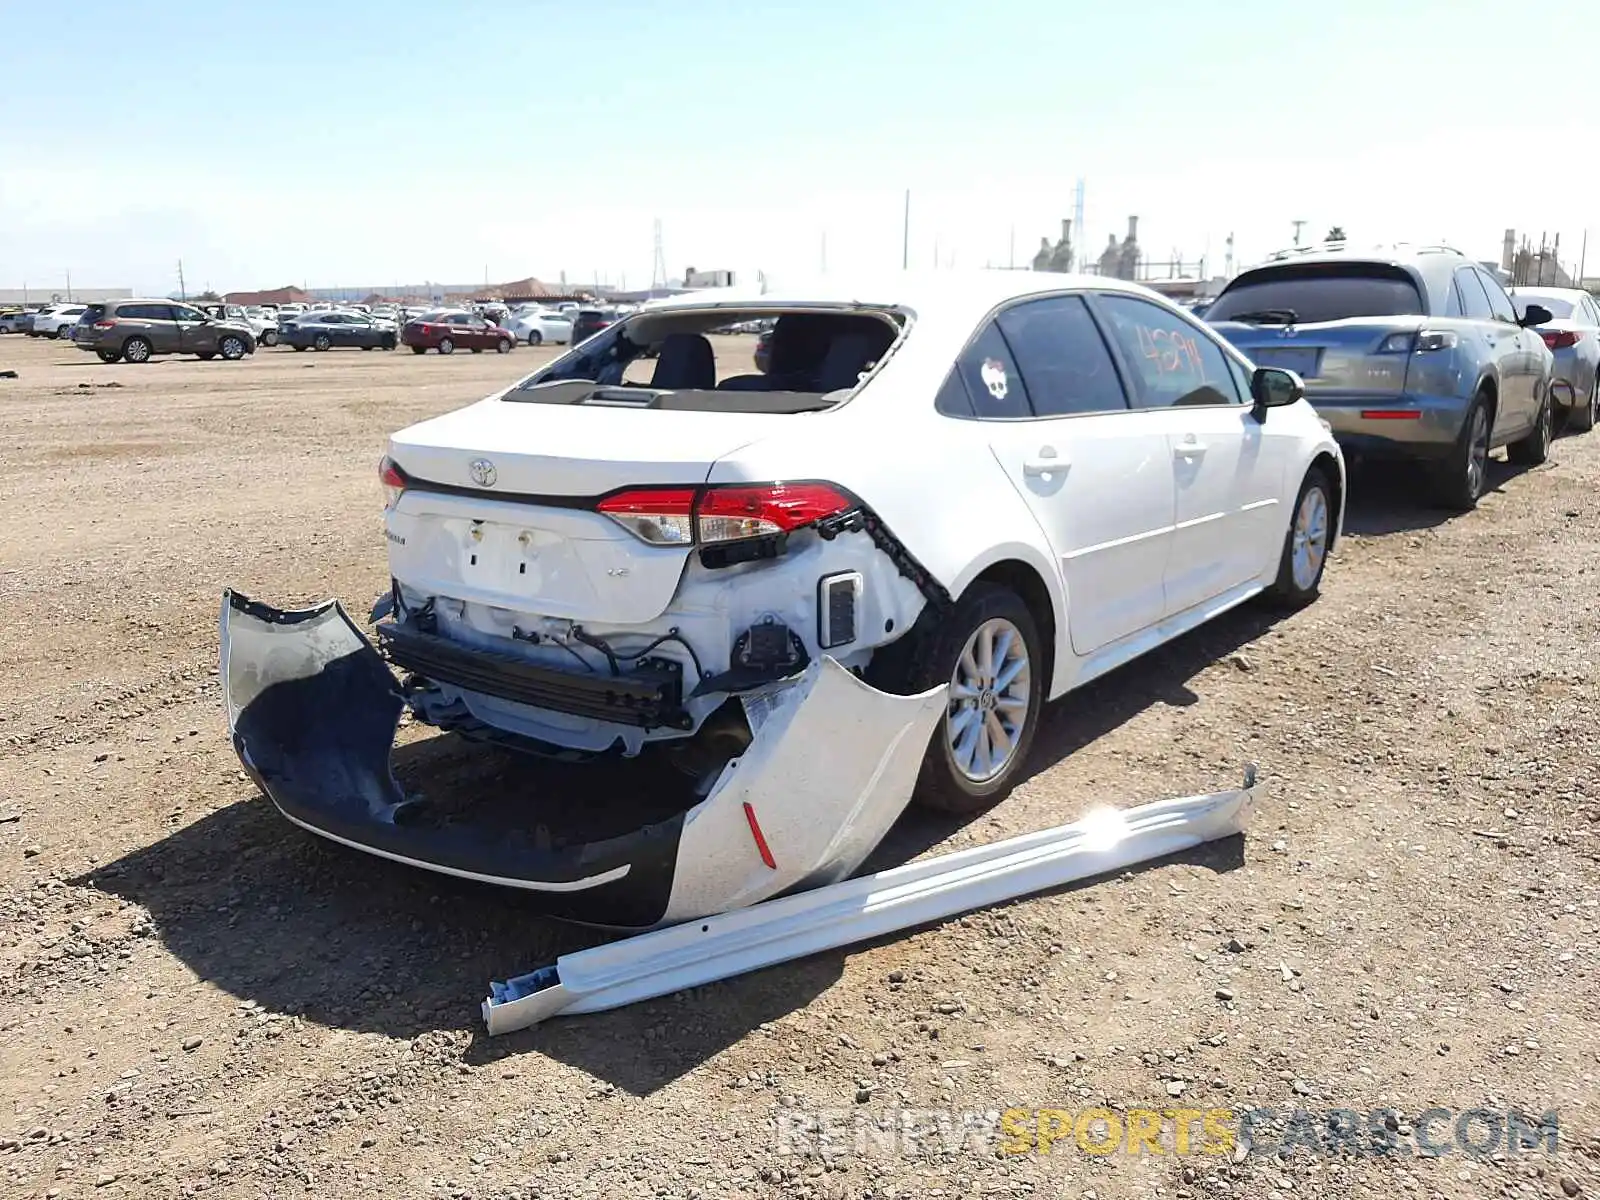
left=995, top=296, right=1128, bottom=416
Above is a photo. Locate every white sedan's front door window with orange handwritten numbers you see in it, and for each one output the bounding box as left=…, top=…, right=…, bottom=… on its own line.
left=1098, top=294, right=1243, bottom=408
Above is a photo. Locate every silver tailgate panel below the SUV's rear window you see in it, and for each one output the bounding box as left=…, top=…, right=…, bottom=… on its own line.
left=1213, top=317, right=1424, bottom=402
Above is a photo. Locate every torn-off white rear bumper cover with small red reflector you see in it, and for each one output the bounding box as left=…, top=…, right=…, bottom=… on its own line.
left=221, top=590, right=946, bottom=930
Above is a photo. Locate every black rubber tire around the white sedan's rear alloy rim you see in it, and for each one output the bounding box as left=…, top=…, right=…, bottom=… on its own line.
left=872, top=582, right=1046, bottom=816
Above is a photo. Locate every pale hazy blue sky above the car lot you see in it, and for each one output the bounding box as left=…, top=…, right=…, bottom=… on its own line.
left=0, top=0, right=1600, bottom=293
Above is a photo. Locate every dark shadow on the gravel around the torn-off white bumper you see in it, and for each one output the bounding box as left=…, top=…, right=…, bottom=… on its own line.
left=72, top=736, right=838, bottom=1086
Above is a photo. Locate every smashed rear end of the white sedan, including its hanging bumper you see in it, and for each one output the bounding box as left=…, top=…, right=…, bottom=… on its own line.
left=221, top=306, right=949, bottom=928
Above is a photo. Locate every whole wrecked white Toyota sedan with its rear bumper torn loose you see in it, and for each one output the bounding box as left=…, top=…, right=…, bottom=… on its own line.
left=224, top=270, right=1346, bottom=923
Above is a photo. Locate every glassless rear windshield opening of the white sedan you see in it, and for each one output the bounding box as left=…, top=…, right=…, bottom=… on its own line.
left=504, top=309, right=901, bottom=413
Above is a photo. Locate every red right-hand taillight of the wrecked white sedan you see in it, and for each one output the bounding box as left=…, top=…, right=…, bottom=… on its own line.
left=595, top=483, right=856, bottom=546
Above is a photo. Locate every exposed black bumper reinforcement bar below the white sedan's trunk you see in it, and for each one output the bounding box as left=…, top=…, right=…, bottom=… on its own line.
left=378, top=622, right=693, bottom=730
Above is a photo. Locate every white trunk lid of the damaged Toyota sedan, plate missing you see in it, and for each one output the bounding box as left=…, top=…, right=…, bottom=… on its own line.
left=387, top=398, right=794, bottom=624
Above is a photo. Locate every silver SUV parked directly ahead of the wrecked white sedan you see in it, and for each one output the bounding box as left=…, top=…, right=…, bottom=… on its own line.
left=1205, top=243, right=1554, bottom=509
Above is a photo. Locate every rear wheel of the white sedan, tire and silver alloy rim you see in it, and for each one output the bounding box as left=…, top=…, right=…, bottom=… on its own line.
left=874, top=584, right=1045, bottom=814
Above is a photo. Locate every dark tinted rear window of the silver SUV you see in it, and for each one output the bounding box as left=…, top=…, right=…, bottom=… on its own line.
left=1205, top=262, right=1427, bottom=325
